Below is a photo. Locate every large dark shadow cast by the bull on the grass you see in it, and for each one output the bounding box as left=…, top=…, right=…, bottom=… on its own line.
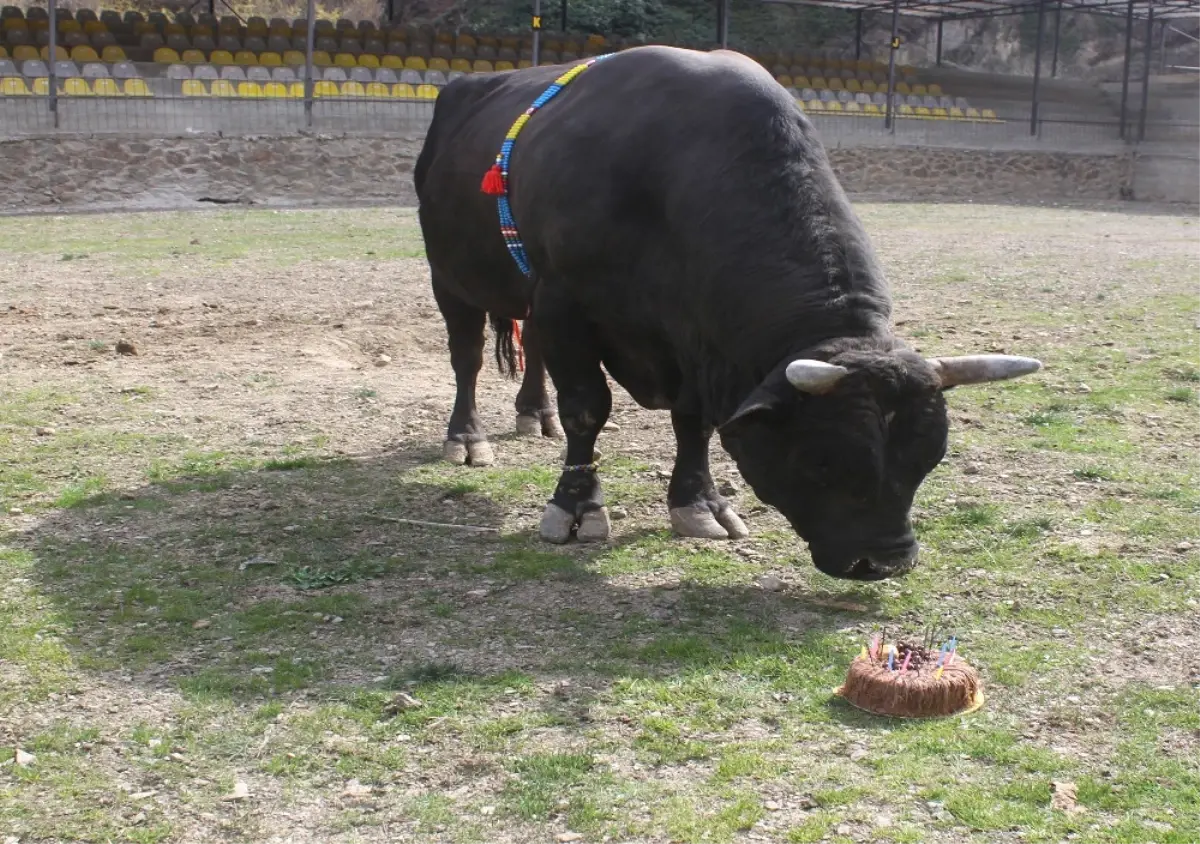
left=13, top=441, right=874, bottom=719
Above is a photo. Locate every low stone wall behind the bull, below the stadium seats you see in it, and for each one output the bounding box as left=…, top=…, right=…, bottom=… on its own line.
left=0, top=134, right=1133, bottom=213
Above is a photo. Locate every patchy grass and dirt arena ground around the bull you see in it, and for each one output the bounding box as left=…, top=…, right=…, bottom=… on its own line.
left=0, top=205, right=1200, bottom=844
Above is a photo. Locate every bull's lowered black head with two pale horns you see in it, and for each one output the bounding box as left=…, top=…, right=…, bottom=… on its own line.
left=720, top=351, right=1042, bottom=580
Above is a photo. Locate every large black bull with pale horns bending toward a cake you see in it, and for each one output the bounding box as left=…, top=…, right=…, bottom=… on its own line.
left=415, top=47, right=1039, bottom=580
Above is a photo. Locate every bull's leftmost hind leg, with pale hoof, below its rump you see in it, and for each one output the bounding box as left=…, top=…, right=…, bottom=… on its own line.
left=433, top=280, right=494, bottom=466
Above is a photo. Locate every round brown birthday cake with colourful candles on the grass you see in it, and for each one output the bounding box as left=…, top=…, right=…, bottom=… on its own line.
left=835, top=636, right=983, bottom=718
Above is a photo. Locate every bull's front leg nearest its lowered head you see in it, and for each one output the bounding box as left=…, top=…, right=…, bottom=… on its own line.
left=667, top=411, right=750, bottom=539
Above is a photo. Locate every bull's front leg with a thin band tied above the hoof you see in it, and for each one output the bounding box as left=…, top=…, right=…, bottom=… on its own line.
left=535, top=297, right=612, bottom=543
